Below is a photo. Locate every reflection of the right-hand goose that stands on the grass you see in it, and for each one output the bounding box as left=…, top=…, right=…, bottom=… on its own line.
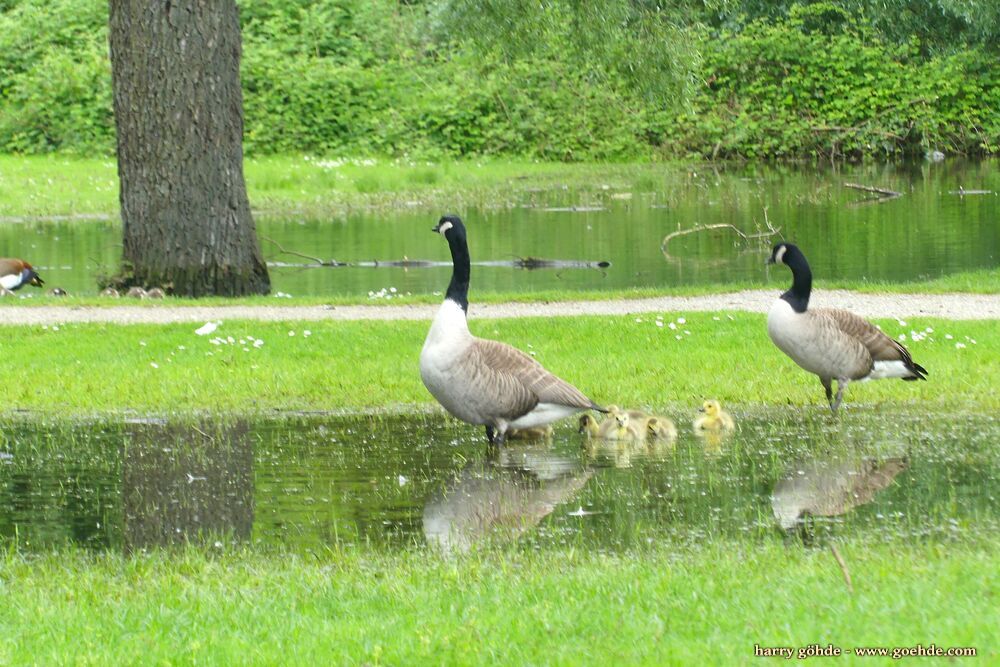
left=771, top=458, right=907, bottom=531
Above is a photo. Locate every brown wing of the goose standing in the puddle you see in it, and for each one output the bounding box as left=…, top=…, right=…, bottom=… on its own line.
left=473, top=339, right=594, bottom=416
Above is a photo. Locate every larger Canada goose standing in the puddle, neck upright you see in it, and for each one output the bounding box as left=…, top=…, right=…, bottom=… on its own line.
left=420, top=215, right=605, bottom=444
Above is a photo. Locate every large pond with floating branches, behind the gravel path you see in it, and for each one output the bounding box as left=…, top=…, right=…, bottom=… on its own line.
left=0, top=160, right=1000, bottom=297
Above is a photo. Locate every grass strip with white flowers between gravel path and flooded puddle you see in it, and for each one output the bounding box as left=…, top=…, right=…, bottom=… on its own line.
left=0, top=313, right=1000, bottom=414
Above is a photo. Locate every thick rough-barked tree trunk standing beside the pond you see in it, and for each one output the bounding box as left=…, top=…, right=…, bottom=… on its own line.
left=109, top=0, right=270, bottom=296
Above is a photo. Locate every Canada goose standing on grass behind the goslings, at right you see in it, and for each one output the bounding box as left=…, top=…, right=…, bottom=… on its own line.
left=767, top=243, right=927, bottom=414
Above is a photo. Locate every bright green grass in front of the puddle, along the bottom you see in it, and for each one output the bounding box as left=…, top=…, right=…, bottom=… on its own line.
left=0, top=535, right=1000, bottom=664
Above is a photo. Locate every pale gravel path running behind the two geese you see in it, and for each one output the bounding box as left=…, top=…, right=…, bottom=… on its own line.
left=0, top=290, right=1000, bottom=326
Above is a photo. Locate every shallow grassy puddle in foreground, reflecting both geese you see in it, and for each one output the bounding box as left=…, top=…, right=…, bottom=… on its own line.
left=0, top=408, right=1000, bottom=552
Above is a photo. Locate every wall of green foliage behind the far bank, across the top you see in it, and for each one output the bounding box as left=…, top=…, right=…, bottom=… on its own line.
left=0, top=0, right=1000, bottom=161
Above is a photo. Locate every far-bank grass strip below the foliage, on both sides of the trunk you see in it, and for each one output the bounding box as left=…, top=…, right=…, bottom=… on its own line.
left=0, top=155, right=669, bottom=219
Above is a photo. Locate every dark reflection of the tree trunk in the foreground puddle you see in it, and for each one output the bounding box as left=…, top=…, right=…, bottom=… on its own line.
left=121, top=421, right=254, bottom=550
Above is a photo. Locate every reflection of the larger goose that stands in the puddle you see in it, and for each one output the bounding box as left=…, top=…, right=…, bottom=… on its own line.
left=424, top=446, right=593, bottom=553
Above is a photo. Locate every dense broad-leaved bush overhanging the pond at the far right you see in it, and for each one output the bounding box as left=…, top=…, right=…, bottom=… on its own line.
left=664, top=3, right=1000, bottom=158
